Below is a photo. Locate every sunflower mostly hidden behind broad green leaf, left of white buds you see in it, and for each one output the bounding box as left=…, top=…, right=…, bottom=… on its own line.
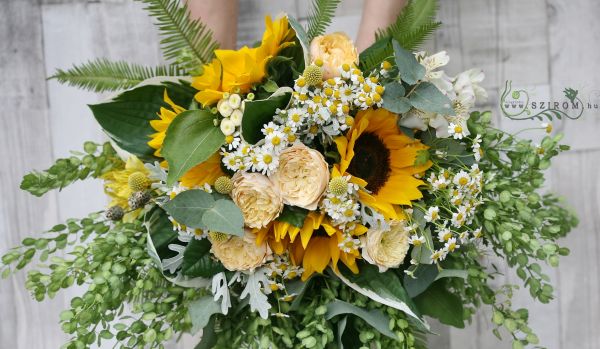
left=148, top=90, right=225, bottom=188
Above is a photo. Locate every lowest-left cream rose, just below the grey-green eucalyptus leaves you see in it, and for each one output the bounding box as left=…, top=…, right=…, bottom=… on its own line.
left=211, top=230, right=271, bottom=271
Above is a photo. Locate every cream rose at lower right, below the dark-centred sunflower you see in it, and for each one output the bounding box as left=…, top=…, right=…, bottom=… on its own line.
left=361, top=221, right=409, bottom=272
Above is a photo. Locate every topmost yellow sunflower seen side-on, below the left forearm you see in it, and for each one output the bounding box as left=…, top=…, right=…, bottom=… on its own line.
left=192, top=16, right=294, bottom=106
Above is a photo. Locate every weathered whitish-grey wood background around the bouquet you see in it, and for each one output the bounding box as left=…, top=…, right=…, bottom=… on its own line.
left=0, top=0, right=600, bottom=349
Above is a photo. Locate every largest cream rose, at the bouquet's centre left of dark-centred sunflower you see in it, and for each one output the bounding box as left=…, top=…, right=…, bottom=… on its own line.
left=271, top=143, right=329, bottom=210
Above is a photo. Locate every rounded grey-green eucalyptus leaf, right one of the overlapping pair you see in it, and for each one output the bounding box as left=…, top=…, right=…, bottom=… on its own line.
left=202, top=200, right=244, bottom=236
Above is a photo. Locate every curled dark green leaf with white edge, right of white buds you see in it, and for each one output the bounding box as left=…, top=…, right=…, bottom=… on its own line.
left=242, top=87, right=292, bottom=144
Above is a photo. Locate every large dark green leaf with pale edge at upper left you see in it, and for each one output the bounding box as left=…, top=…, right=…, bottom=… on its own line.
left=89, top=83, right=194, bottom=160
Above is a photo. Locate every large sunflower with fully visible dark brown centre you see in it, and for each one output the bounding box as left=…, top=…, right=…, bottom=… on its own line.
left=335, top=109, right=431, bottom=220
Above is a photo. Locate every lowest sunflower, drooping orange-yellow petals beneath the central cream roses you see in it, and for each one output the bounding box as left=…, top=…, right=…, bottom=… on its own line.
left=257, top=212, right=367, bottom=281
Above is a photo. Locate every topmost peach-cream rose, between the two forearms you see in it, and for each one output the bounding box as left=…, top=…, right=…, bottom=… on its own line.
left=310, top=32, right=358, bottom=79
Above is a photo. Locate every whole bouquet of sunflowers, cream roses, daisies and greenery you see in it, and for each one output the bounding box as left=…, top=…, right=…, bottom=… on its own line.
left=2, top=0, right=577, bottom=348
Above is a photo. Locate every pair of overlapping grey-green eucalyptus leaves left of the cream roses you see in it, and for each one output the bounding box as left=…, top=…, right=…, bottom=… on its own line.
left=163, top=189, right=244, bottom=236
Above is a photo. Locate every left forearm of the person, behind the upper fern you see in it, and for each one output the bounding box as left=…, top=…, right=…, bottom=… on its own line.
left=187, top=0, right=239, bottom=49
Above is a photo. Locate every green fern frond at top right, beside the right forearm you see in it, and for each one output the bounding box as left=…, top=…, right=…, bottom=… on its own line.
left=360, top=0, right=441, bottom=71
